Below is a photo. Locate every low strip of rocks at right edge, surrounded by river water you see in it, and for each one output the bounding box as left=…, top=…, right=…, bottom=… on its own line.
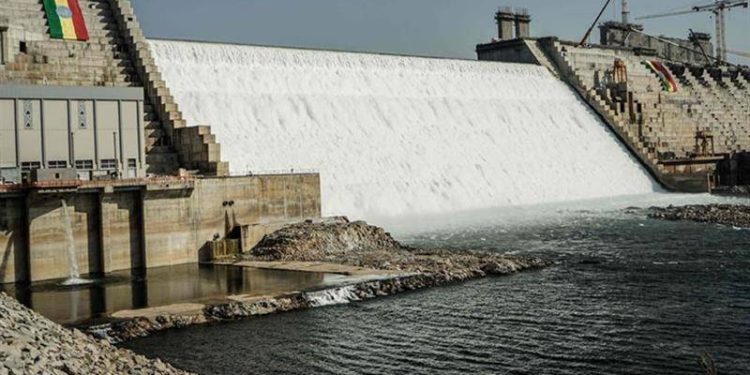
left=648, top=204, right=750, bottom=228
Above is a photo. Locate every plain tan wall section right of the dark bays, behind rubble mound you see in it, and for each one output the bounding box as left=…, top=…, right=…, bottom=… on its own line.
left=144, top=174, right=320, bottom=267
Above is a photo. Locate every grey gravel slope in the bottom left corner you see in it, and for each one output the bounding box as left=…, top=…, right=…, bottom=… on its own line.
left=0, top=293, right=192, bottom=375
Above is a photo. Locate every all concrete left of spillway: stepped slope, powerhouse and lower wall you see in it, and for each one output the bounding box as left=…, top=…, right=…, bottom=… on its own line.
left=0, top=0, right=320, bottom=283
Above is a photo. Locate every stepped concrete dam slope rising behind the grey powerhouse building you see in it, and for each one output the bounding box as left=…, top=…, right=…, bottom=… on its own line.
left=0, top=0, right=228, bottom=176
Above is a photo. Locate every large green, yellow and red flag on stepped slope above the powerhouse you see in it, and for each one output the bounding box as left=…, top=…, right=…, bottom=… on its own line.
left=44, top=0, right=89, bottom=40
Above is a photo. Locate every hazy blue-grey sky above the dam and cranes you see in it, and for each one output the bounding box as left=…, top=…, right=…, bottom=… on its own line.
left=132, top=0, right=750, bottom=64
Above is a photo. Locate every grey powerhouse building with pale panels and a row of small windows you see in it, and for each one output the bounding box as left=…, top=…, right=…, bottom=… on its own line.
left=0, top=85, right=146, bottom=183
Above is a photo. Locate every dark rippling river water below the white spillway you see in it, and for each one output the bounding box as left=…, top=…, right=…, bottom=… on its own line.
left=122, top=213, right=750, bottom=374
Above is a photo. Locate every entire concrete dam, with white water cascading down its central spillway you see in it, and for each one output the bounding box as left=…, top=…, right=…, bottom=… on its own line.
left=0, top=0, right=750, bottom=282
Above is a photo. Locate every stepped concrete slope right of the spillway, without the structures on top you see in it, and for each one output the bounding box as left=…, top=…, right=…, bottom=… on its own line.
left=524, top=38, right=750, bottom=192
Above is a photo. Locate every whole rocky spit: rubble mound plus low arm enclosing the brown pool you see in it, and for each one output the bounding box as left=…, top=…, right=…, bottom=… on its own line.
left=90, top=218, right=549, bottom=342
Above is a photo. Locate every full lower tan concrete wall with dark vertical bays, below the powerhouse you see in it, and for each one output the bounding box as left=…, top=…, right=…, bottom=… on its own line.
left=0, top=174, right=321, bottom=282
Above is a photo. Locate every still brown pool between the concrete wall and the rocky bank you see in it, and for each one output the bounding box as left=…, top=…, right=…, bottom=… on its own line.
left=1, top=264, right=325, bottom=325
